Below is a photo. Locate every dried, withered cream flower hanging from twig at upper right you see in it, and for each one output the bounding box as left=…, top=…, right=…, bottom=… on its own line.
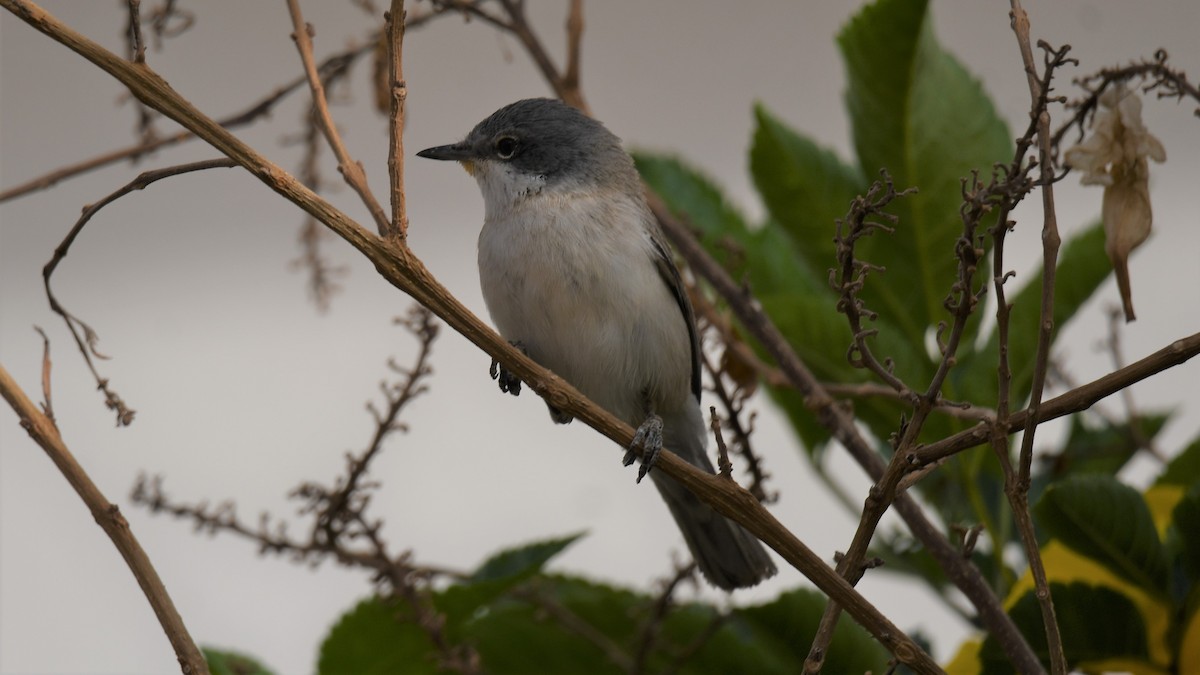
left=1066, top=84, right=1166, bottom=321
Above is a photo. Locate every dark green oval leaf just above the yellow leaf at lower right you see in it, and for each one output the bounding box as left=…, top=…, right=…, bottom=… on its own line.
left=1036, top=476, right=1168, bottom=597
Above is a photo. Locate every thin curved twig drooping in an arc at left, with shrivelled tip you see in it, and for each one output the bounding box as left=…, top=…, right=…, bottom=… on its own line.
left=42, top=159, right=238, bottom=426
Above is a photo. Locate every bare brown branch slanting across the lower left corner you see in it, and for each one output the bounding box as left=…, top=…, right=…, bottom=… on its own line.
left=0, top=365, right=209, bottom=675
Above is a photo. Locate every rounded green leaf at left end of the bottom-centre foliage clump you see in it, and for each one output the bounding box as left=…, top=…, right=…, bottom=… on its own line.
left=317, top=598, right=440, bottom=675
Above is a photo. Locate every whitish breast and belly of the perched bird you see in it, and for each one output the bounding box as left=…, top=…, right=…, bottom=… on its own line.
left=479, top=180, right=695, bottom=426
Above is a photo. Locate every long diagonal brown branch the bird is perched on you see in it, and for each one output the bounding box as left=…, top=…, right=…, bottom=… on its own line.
left=0, top=6, right=941, bottom=673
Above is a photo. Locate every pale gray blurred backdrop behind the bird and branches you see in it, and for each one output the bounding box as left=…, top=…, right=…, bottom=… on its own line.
left=0, top=0, right=1200, bottom=674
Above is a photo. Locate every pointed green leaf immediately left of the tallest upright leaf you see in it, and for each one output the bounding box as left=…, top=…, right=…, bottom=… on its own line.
left=750, top=104, right=866, bottom=271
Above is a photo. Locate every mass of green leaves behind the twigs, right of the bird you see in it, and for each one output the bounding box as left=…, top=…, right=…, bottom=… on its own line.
left=635, top=0, right=1200, bottom=669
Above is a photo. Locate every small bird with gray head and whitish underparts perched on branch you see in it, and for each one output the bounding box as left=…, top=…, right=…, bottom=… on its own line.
left=418, top=98, right=775, bottom=590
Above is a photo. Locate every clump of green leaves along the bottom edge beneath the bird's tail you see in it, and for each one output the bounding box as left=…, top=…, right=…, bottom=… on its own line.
left=317, top=537, right=888, bottom=675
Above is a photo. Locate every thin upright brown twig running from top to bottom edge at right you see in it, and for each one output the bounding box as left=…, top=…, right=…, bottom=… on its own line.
left=1008, top=0, right=1067, bottom=675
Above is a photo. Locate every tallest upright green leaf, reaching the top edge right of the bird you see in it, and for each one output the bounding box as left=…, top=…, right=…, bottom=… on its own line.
left=838, top=0, right=1013, bottom=345
